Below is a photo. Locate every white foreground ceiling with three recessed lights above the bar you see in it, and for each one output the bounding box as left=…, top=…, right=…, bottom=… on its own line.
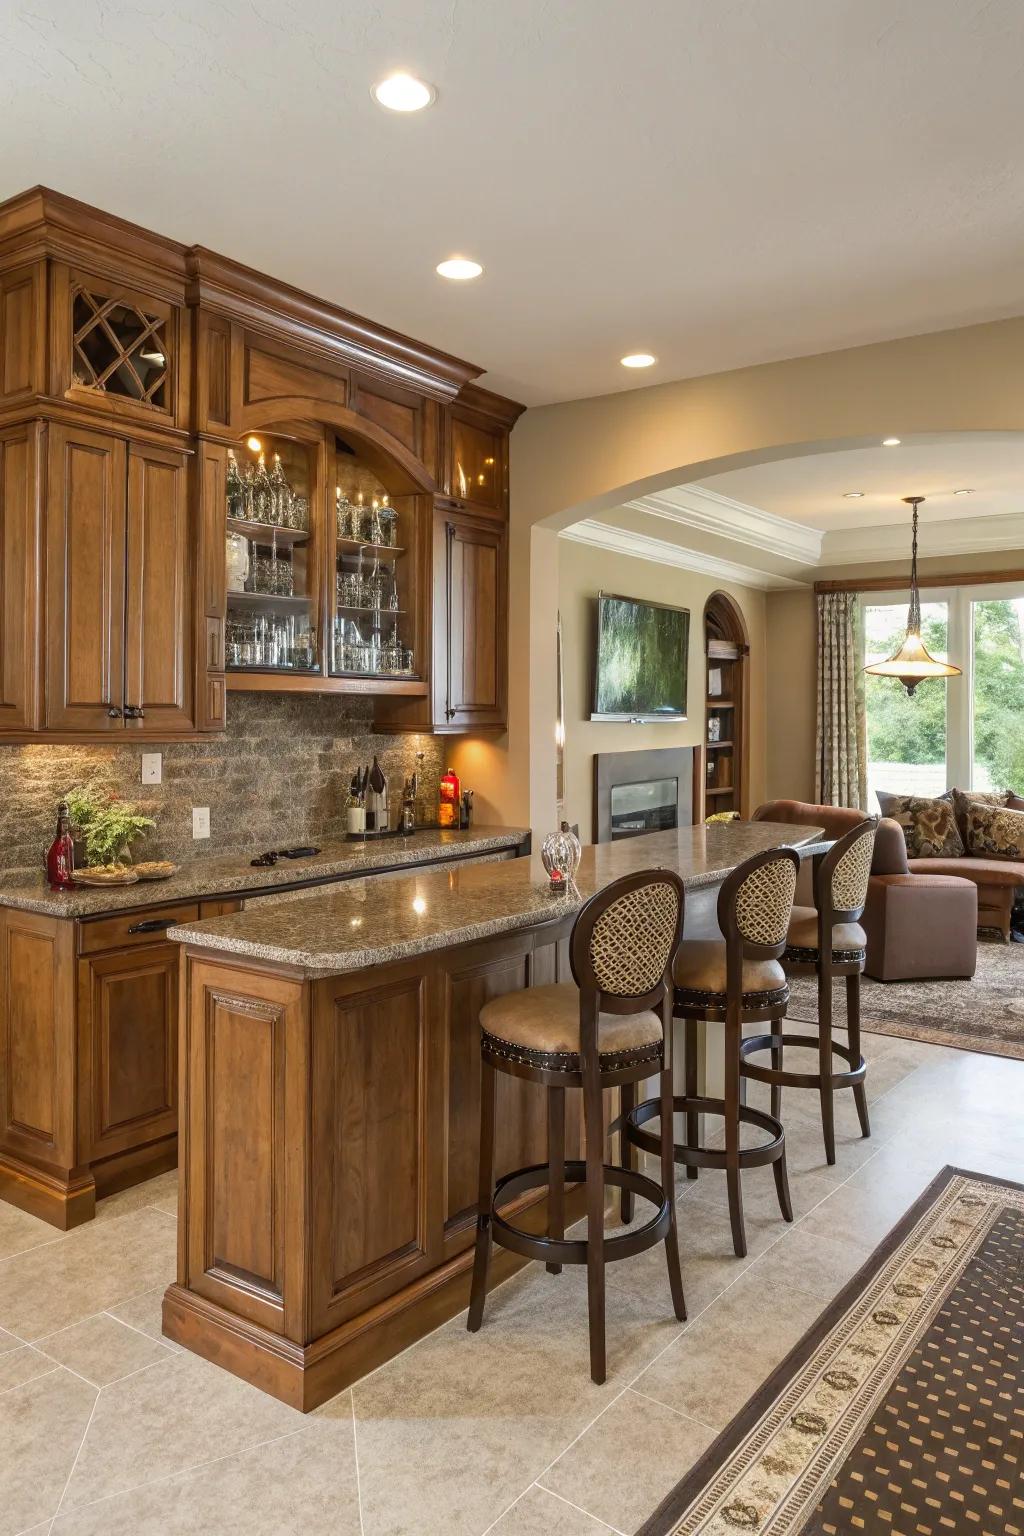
left=0, top=0, right=1024, bottom=404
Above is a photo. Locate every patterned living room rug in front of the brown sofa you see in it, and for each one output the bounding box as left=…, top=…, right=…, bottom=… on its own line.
left=789, top=943, right=1024, bottom=1062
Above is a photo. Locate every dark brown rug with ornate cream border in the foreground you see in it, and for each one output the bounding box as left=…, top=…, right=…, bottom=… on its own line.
left=639, top=1167, right=1024, bottom=1536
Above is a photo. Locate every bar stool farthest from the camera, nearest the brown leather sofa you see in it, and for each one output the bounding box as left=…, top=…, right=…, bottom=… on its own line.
left=742, top=820, right=878, bottom=1163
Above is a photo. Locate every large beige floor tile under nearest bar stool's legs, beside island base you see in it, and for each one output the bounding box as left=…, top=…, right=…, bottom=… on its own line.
left=353, top=1267, right=680, bottom=1536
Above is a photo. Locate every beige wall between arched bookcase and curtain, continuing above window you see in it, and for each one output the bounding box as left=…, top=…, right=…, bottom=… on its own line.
left=765, top=550, right=1024, bottom=800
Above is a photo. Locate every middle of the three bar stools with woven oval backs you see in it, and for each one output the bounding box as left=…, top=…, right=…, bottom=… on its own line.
left=622, top=848, right=800, bottom=1258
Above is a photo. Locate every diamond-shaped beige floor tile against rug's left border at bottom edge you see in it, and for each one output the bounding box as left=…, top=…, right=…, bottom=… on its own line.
left=539, top=1392, right=715, bottom=1533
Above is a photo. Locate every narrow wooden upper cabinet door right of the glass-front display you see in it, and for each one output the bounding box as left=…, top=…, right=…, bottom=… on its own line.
left=434, top=513, right=508, bottom=730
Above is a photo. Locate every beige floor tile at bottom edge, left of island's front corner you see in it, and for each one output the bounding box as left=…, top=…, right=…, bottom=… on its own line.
left=52, top=1419, right=359, bottom=1536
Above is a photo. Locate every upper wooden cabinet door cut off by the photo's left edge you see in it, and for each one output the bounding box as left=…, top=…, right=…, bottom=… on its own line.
left=0, top=425, right=41, bottom=736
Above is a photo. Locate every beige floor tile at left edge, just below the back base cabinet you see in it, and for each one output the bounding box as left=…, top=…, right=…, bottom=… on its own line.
left=0, top=1209, right=177, bottom=1341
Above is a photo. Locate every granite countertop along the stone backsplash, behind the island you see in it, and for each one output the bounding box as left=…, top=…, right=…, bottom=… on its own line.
left=0, top=826, right=527, bottom=917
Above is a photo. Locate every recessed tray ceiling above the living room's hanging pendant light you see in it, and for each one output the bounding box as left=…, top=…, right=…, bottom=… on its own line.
left=702, top=433, right=1024, bottom=533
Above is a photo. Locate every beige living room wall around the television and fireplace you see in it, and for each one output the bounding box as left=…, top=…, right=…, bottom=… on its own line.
left=555, top=539, right=765, bottom=843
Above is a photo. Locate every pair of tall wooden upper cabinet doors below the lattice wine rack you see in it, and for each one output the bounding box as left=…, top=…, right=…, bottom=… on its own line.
left=45, top=427, right=193, bottom=734
